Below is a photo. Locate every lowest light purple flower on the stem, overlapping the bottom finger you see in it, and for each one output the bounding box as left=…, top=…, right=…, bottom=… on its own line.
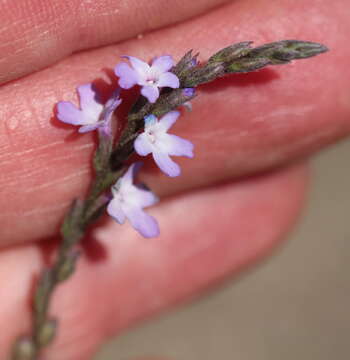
left=107, top=162, right=159, bottom=238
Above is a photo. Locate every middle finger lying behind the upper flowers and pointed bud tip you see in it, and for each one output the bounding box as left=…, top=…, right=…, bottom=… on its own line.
left=0, top=0, right=350, bottom=244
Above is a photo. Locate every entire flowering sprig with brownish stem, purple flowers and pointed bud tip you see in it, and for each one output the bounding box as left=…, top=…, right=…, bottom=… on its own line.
left=12, top=40, right=327, bottom=360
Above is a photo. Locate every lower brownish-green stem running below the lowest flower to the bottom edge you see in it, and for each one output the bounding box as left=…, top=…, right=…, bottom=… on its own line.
left=13, top=167, right=117, bottom=360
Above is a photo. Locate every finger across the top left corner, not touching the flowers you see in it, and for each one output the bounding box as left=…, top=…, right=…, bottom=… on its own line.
left=0, top=0, right=227, bottom=83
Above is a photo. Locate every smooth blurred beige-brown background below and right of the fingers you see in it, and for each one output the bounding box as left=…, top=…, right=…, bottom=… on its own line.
left=95, top=141, right=350, bottom=360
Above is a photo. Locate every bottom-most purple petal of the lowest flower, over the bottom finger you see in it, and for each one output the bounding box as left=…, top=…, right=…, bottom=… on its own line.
left=124, top=207, right=159, bottom=238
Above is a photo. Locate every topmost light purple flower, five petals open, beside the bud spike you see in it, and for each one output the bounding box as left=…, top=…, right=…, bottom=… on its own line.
left=115, top=55, right=180, bottom=103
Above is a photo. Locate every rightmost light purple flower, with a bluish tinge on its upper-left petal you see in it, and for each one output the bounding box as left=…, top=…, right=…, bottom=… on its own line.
left=134, top=111, right=193, bottom=177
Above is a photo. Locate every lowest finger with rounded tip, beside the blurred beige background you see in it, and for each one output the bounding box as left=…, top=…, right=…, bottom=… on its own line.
left=0, top=163, right=305, bottom=360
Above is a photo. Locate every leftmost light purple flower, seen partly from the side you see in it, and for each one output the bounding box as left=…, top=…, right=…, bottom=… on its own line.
left=57, top=84, right=122, bottom=133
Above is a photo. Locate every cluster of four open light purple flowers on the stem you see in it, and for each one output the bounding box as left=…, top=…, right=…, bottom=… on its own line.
left=57, top=55, right=194, bottom=237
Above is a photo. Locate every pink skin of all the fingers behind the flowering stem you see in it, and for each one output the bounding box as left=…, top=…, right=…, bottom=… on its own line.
left=0, top=0, right=350, bottom=360
